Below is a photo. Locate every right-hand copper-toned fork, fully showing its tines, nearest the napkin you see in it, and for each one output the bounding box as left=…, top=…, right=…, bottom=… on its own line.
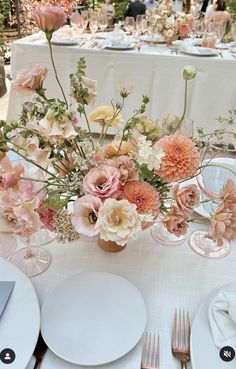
left=172, top=310, right=190, bottom=369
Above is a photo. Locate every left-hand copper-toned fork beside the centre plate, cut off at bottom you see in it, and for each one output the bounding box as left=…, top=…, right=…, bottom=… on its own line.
left=141, top=332, right=160, bottom=369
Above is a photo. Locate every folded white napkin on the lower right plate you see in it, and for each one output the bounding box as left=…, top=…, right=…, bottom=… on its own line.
left=208, top=291, right=236, bottom=348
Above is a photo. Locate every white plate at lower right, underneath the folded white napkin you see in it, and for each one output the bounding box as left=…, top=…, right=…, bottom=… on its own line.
left=191, top=281, right=236, bottom=369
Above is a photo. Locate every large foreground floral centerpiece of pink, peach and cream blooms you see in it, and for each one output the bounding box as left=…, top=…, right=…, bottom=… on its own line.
left=0, top=7, right=236, bottom=258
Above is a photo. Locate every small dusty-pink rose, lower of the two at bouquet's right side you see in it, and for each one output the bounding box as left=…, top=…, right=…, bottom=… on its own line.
left=162, top=206, right=188, bottom=237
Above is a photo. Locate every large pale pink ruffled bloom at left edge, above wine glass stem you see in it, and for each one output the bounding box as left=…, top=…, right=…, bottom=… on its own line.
left=0, top=193, right=40, bottom=236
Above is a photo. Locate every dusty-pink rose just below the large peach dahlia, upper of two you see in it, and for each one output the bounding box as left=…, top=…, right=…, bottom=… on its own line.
left=173, top=185, right=200, bottom=214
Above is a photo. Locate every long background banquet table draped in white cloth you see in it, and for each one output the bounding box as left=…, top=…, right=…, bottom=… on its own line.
left=8, top=34, right=236, bottom=135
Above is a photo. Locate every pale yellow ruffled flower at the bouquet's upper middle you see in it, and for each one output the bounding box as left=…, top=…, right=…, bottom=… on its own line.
left=89, top=105, right=123, bottom=127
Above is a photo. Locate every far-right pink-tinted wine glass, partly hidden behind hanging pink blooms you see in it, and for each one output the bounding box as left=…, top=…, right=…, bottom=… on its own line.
left=189, top=158, right=236, bottom=259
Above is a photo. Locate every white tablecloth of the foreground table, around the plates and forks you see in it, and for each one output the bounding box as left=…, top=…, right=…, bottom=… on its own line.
left=19, top=224, right=236, bottom=369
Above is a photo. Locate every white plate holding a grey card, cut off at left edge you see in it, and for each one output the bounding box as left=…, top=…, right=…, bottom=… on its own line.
left=0, top=258, right=40, bottom=369
